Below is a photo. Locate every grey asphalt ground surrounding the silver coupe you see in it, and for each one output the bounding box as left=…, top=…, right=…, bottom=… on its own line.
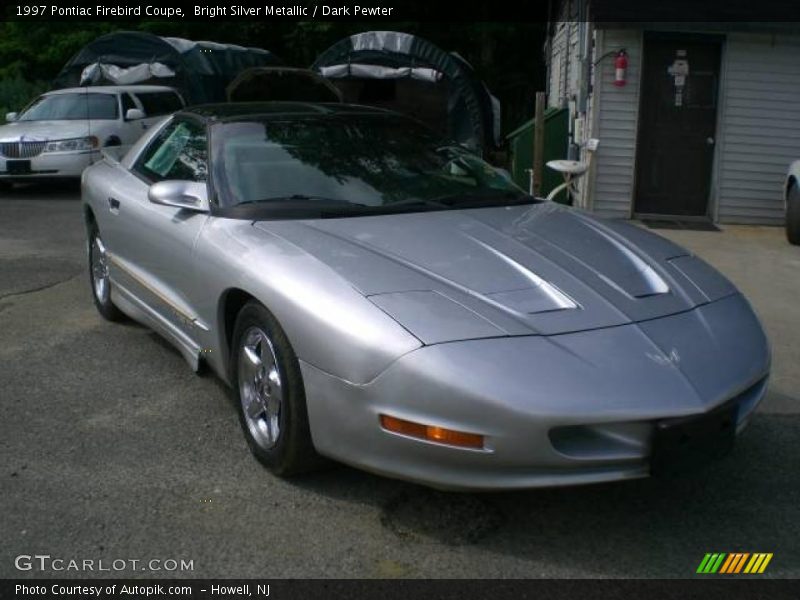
left=0, top=186, right=800, bottom=578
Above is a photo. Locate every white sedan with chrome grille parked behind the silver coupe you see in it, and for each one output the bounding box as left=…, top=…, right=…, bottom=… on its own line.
left=0, top=85, right=184, bottom=186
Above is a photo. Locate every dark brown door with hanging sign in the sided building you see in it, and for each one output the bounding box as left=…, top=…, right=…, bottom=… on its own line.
left=634, top=33, right=721, bottom=216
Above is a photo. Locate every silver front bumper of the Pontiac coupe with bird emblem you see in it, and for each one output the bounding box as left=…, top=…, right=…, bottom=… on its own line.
left=301, top=295, right=770, bottom=490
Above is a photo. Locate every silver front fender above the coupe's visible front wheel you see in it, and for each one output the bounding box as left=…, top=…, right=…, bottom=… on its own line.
left=196, top=218, right=422, bottom=384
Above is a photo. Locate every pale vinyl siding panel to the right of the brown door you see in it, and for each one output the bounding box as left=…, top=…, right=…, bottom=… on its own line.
left=717, top=33, right=800, bottom=225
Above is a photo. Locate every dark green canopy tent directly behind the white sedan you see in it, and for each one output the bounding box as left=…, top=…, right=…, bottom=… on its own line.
left=54, top=31, right=282, bottom=104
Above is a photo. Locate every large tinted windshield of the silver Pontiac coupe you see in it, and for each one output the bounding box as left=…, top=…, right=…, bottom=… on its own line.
left=212, top=115, right=534, bottom=216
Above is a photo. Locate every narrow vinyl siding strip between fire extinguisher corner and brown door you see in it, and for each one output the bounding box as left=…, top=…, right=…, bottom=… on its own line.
left=590, top=29, right=642, bottom=218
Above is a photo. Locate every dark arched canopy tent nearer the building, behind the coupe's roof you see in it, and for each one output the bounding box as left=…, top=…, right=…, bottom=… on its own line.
left=311, top=31, right=500, bottom=150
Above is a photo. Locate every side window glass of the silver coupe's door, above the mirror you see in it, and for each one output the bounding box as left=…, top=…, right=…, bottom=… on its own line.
left=133, top=120, right=208, bottom=182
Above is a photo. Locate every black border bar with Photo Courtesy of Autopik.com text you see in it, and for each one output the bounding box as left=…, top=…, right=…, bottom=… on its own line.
left=0, top=575, right=798, bottom=600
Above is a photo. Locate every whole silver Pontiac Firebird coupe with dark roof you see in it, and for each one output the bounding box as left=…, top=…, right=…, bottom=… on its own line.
left=83, top=103, right=770, bottom=490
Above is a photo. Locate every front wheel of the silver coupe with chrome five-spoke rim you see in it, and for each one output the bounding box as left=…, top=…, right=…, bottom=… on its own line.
left=231, top=302, right=321, bottom=477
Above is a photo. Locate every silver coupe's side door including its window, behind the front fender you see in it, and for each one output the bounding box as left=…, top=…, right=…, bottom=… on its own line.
left=109, top=118, right=209, bottom=349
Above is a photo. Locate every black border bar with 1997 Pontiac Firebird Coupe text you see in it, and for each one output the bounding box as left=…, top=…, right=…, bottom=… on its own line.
left=0, top=0, right=800, bottom=22
